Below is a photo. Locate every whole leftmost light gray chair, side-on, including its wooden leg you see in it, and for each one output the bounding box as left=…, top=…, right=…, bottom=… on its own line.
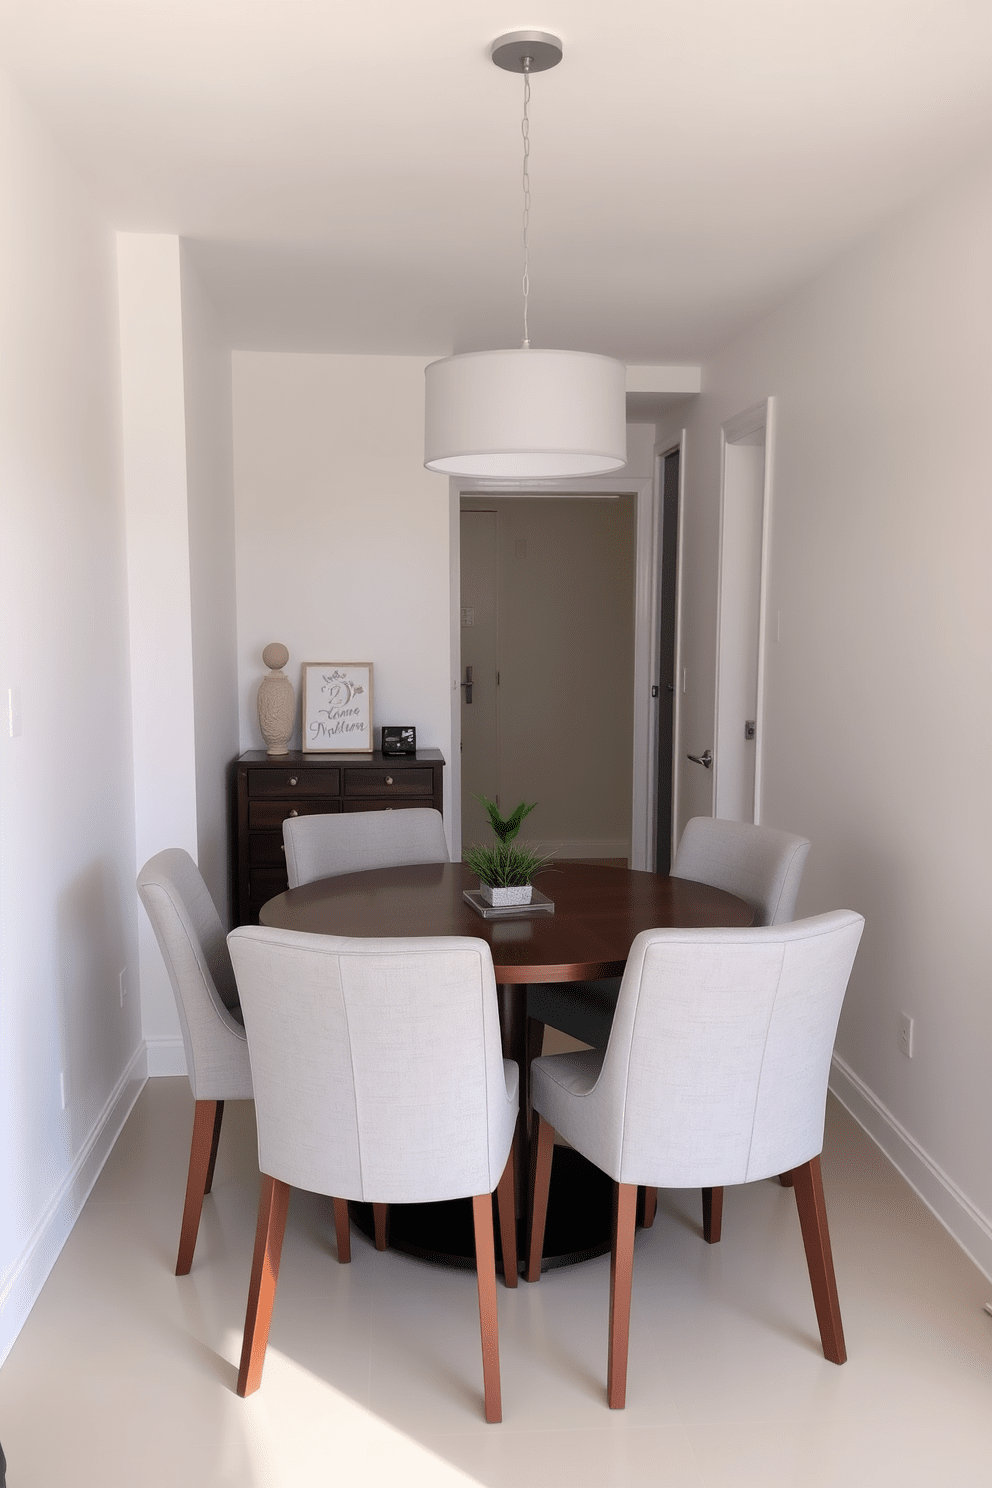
left=138, top=847, right=251, bottom=1277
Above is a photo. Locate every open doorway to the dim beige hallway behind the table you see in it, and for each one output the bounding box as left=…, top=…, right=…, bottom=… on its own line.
left=460, top=494, right=637, bottom=863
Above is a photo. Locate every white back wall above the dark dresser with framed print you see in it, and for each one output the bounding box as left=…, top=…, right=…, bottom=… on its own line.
left=233, top=351, right=452, bottom=817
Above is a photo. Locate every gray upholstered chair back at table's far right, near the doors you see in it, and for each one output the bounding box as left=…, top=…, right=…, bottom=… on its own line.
left=672, top=817, right=809, bottom=926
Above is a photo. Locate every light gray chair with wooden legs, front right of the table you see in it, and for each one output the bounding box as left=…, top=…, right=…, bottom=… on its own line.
left=526, top=909, right=864, bottom=1409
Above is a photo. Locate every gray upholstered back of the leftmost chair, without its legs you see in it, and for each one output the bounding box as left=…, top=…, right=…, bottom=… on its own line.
left=138, top=847, right=251, bottom=1101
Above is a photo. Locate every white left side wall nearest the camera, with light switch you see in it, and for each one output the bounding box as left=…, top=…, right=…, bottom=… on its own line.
left=0, top=77, right=141, bottom=1359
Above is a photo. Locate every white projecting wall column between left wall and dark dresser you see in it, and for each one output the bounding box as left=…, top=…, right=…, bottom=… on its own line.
left=117, top=232, right=238, bottom=1074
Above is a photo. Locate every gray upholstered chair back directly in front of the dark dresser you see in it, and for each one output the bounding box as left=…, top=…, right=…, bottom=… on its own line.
left=283, top=806, right=448, bottom=888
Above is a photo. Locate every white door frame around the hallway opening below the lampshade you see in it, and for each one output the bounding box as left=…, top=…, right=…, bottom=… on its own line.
left=448, top=473, right=660, bottom=869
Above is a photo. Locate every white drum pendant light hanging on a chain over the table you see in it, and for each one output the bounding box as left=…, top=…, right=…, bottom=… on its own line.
left=424, top=31, right=626, bottom=481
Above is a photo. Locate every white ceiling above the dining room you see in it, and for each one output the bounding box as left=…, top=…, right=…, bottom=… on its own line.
left=0, top=0, right=992, bottom=363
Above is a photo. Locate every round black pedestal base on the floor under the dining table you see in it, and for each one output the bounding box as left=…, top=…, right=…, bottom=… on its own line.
left=350, top=1146, right=613, bottom=1271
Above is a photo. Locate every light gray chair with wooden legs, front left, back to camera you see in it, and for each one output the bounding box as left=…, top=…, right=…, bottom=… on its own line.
left=228, top=926, right=518, bottom=1421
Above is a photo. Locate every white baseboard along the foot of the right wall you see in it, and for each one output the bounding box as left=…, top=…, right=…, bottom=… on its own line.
left=830, top=1054, right=992, bottom=1281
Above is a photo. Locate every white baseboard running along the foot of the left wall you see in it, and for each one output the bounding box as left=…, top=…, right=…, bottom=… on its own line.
left=0, top=1045, right=147, bottom=1364
